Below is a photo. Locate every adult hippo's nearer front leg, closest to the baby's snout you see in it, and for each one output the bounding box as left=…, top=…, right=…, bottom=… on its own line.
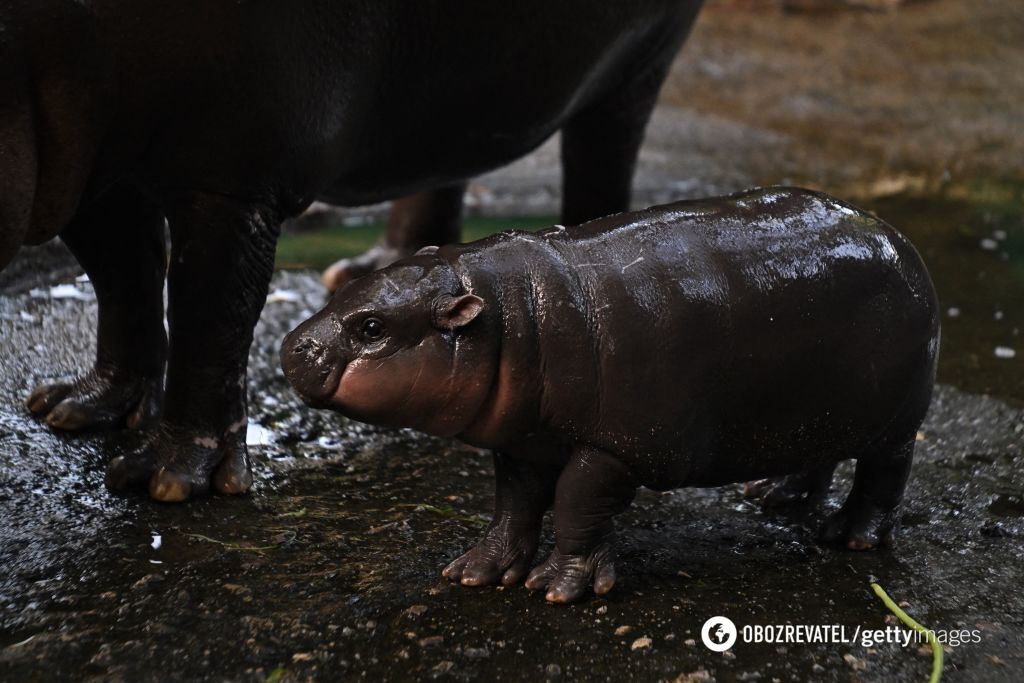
left=106, top=194, right=280, bottom=502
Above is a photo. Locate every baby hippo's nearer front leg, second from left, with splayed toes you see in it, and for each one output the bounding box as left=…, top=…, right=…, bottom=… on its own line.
left=526, top=446, right=637, bottom=603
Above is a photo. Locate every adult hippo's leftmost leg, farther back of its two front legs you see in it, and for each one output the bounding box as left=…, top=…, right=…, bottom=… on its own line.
left=26, top=188, right=167, bottom=431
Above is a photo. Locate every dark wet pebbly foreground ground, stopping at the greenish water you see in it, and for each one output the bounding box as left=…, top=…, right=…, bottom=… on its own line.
left=0, top=222, right=1024, bottom=681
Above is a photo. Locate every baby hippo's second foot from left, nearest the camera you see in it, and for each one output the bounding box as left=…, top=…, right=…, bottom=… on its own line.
left=526, top=543, right=615, bottom=604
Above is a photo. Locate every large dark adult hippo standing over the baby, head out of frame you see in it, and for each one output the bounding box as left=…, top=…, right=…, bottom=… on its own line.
left=0, top=0, right=700, bottom=502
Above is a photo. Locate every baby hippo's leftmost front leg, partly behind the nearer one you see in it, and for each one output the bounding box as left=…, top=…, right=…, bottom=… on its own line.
left=441, top=453, right=558, bottom=586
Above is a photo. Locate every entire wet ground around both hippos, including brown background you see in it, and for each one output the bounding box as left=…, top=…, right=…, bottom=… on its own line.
left=0, top=0, right=1024, bottom=681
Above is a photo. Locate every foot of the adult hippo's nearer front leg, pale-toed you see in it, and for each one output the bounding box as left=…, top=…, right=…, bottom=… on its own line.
left=106, top=422, right=252, bottom=503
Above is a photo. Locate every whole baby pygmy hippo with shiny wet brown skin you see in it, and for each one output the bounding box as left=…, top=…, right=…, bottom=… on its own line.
left=282, top=188, right=939, bottom=602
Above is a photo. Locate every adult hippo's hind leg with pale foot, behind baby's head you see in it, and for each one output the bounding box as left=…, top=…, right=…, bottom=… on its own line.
left=323, top=183, right=466, bottom=292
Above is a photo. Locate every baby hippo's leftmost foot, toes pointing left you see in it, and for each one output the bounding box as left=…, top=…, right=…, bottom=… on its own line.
left=441, top=519, right=539, bottom=586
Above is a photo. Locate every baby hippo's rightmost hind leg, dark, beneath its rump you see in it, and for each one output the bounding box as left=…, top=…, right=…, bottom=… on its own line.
left=821, top=434, right=915, bottom=550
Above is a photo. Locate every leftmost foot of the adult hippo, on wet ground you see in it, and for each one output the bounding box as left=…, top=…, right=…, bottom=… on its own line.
left=25, top=370, right=163, bottom=431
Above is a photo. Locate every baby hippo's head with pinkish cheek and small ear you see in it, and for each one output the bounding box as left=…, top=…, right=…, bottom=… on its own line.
left=281, top=253, right=489, bottom=435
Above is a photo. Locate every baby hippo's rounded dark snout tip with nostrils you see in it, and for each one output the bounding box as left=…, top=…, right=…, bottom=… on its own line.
left=281, top=314, right=345, bottom=407
